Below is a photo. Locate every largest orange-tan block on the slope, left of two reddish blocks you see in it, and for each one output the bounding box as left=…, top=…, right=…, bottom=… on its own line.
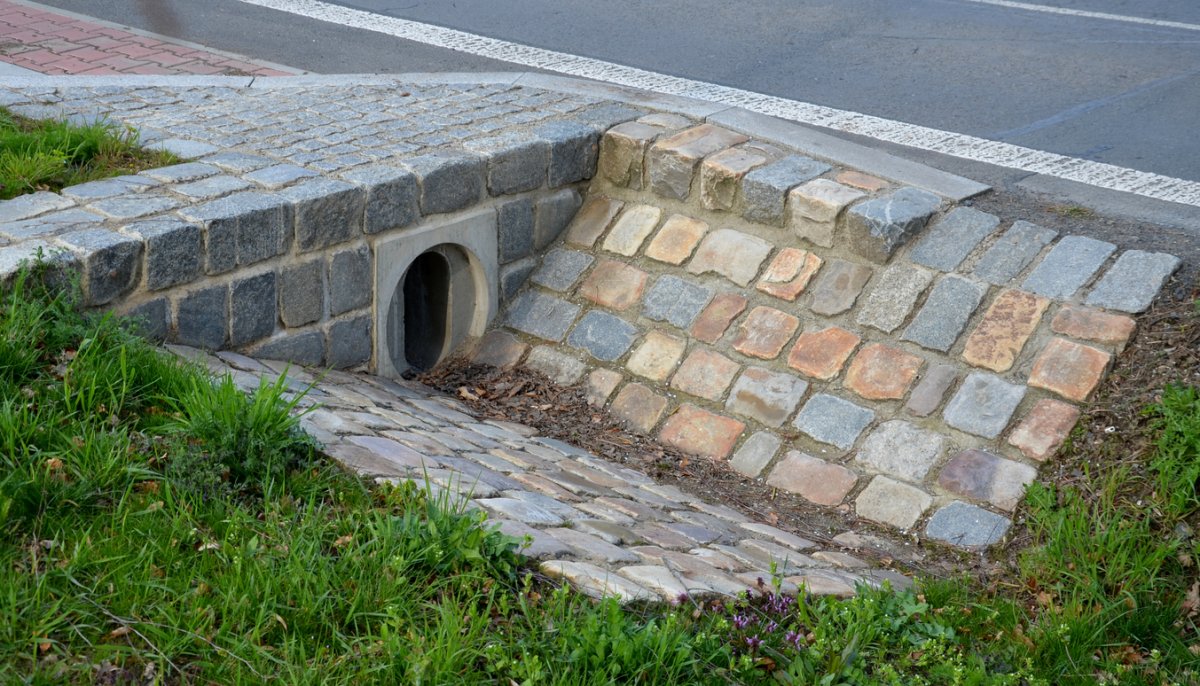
left=962, top=290, right=1050, bottom=372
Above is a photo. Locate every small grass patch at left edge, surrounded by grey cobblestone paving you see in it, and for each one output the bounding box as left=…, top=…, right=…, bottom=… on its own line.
left=0, top=108, right=178, bottom=200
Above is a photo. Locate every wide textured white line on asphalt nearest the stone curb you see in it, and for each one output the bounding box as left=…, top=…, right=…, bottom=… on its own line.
left=240, top=0, right=1200, bottom=206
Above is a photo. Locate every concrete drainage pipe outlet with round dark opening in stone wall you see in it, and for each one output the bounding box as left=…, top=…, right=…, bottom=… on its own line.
left=376, top=210, right=499, bottom=378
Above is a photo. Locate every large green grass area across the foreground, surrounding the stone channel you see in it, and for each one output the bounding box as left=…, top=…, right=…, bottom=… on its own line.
left=0, top=260, right=1200, bottom=686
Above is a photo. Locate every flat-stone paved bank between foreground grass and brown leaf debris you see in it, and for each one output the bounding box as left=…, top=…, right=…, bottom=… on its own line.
left=168, top=345, right=910, bottom=601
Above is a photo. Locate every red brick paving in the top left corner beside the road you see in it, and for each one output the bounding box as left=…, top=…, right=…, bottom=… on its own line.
left=0, top=0, right=292, bottom=77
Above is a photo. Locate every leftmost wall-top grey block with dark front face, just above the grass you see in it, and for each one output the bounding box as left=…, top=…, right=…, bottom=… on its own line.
left=59, top=229, right=143, bottom=306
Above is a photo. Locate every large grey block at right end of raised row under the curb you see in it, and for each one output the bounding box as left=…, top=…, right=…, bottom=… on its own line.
left=846, top=188, right=942, bottom=263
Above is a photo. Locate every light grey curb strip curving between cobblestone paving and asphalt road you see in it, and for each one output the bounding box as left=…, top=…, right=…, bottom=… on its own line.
left=5, top=72, right=990, bottom=201
